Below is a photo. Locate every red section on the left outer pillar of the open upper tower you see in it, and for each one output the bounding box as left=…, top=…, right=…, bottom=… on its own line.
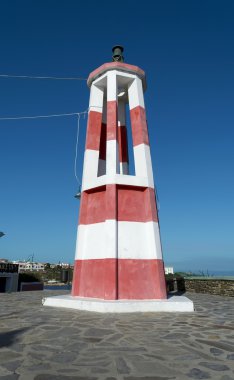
left=86, top=111, right=102, bottom=150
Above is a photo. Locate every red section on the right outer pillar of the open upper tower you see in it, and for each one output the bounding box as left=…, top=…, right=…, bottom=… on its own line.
left=130, top=106, right=149, bottom=146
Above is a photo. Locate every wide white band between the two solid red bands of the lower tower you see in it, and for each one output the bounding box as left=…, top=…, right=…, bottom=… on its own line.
left=75, top=220, right=162, bottom=260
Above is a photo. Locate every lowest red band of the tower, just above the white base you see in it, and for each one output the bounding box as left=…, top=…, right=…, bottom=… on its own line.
left=72, top=259, right=167, bottom=300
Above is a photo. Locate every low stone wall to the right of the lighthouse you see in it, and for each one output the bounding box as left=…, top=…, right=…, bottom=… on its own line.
left=184, top=278, right=234, bottom=297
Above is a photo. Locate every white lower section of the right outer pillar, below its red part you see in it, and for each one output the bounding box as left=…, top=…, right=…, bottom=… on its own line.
left=133, top=144, right=154, bottom=187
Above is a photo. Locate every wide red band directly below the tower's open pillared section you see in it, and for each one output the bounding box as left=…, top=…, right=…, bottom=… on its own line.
left=79, top=185, right=158, bottom=224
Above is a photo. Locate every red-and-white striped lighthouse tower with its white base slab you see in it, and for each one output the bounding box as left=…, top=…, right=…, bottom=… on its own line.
left=44, top=46, right=193, bottom=312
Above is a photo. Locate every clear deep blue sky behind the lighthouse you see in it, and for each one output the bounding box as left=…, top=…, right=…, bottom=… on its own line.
left=0, top=0, right=234, bottom=271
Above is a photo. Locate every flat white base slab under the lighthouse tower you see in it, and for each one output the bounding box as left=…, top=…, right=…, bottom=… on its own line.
left=42, top=295, right=194, bottom=313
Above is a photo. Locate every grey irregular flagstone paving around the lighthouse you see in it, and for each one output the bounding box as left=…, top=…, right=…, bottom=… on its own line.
left=0, top=291, right=234, bottom=380
